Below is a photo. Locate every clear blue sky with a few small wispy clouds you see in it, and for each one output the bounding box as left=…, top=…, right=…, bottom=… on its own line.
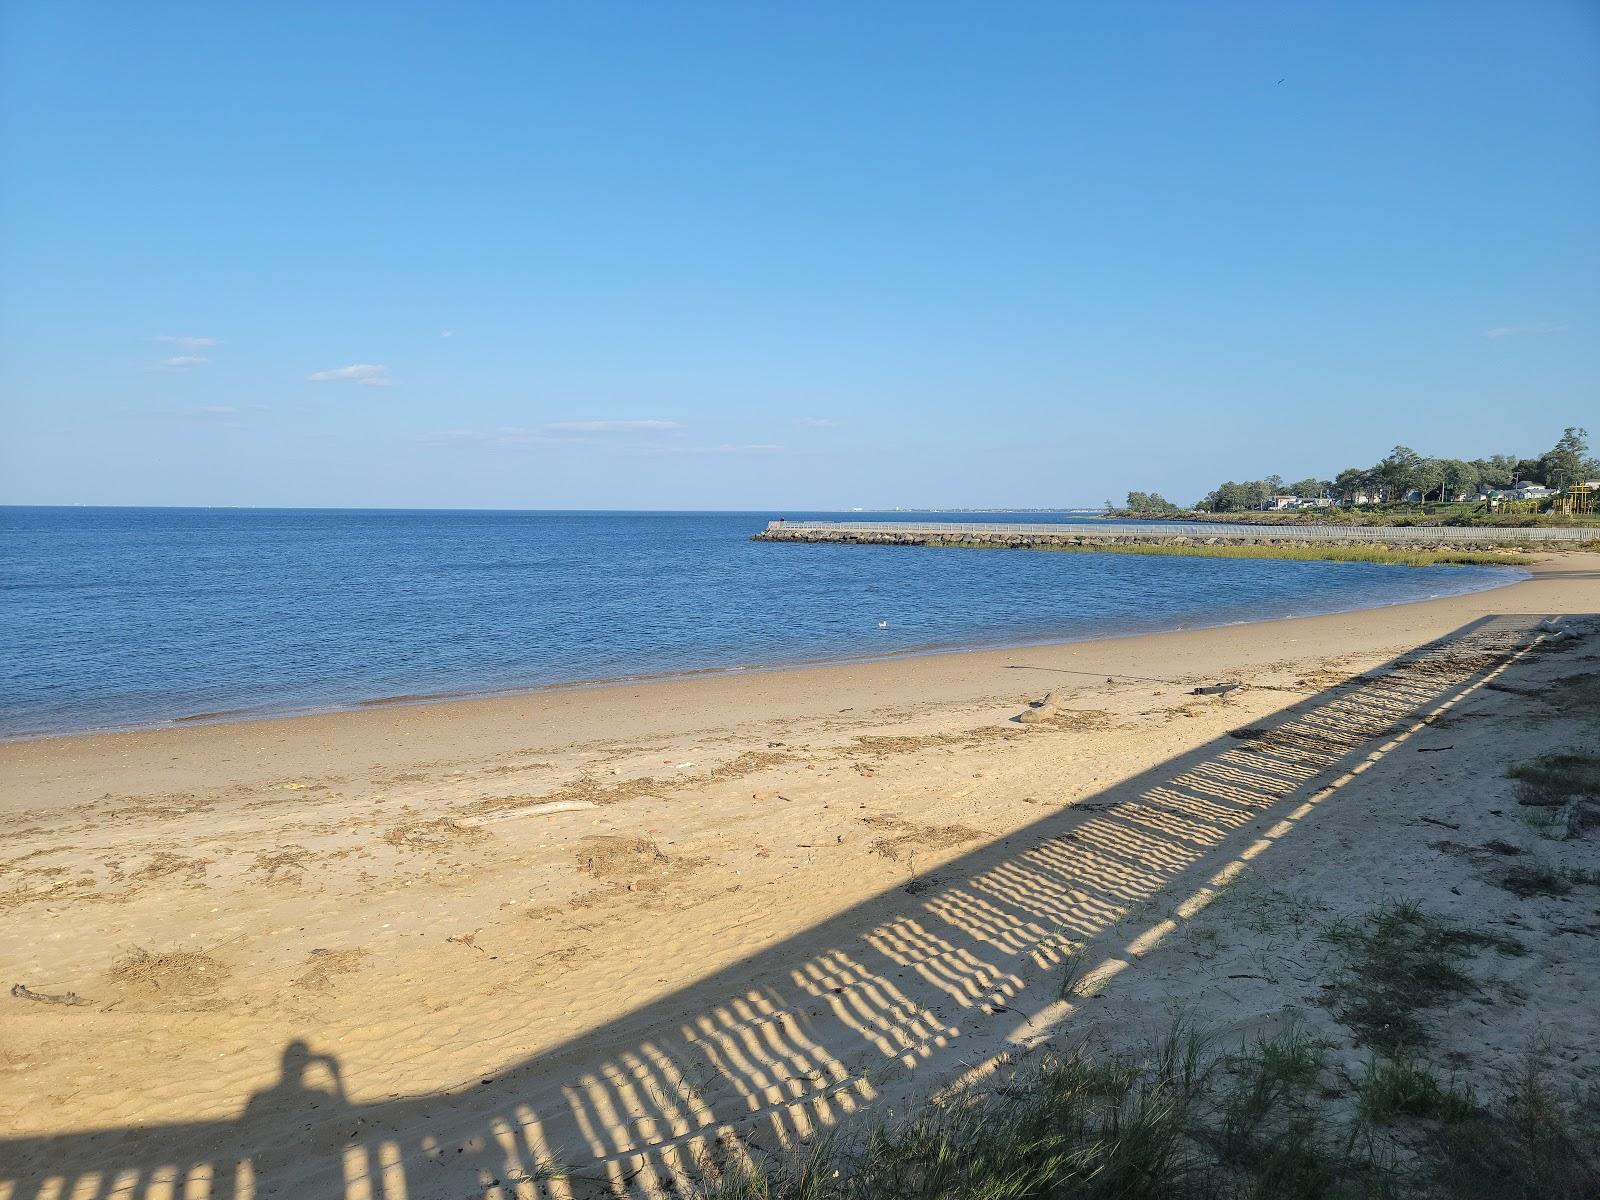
left=0, top=0, right=1600, bottom=510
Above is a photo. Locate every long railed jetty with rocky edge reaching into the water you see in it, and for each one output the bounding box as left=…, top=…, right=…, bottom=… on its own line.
left=754, top=520, right=1600, bottom=550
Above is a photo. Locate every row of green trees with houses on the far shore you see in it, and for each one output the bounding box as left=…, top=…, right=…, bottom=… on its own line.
left=1106, top=426, right=1600, bottom=512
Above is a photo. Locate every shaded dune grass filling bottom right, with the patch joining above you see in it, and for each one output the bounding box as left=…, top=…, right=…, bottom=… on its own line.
left=701, top=904, right=1600, bottom=1200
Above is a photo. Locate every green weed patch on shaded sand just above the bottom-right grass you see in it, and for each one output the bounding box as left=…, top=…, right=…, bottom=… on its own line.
left=1326, top=902, right=1525, bottom=1058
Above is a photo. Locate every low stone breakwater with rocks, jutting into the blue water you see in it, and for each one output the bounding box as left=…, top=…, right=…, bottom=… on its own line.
left=752, top=525, right=1549, bottom=552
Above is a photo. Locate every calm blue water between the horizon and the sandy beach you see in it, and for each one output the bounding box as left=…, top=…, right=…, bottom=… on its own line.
left=0, top=509, right=1509, bottom=736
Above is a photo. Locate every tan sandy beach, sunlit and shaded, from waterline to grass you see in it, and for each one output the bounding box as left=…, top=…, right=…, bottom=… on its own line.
left=0, top=555, right=1600, bottom=1200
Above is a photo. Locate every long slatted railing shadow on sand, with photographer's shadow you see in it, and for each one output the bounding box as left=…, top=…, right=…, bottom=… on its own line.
left=0, top=616, right=1561, bottom=1200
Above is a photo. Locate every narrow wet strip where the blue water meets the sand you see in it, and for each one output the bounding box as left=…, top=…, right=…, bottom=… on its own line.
left=0, top=560, right=1544, bottom=749
